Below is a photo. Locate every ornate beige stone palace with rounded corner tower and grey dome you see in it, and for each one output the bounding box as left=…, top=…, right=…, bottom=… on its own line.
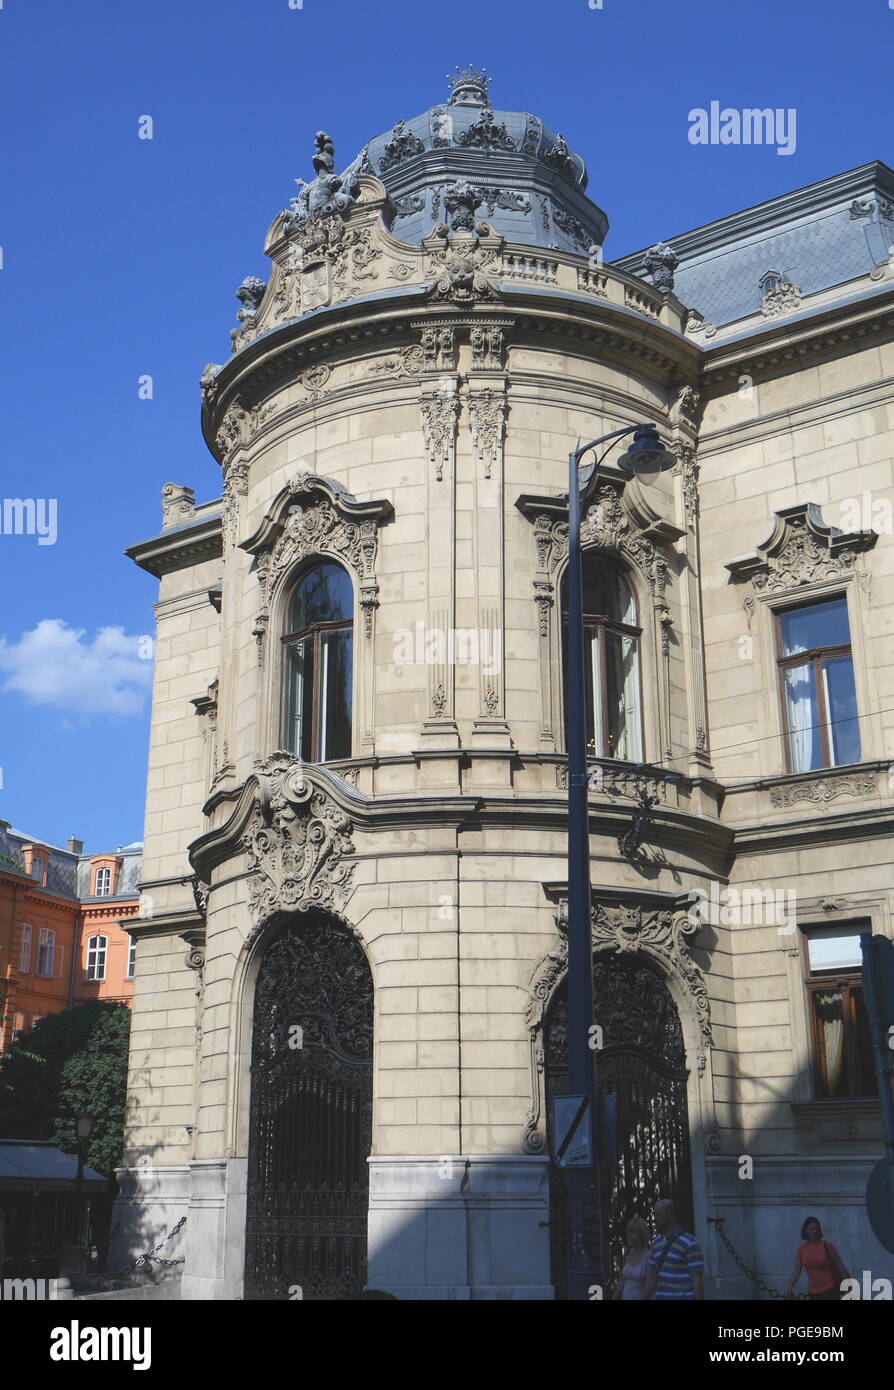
left=113, top=70, right=894, bottom=1298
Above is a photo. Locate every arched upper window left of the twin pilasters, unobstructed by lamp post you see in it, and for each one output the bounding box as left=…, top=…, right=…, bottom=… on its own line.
left=282, top=563, right=353, bottom=763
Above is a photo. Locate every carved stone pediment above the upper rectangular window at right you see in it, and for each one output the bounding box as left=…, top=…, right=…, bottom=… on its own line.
left=727, top=502, right=877, bottom=594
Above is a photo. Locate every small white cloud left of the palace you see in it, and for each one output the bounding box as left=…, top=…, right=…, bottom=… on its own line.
left=0, top=617, right=152, bottom=714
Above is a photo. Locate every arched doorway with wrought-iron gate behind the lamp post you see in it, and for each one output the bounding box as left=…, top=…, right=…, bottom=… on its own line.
left=544, top=951, right=692, bottom=1298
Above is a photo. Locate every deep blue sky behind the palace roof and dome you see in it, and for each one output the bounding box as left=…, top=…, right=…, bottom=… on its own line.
left=0, top=0, right=894, bottom=851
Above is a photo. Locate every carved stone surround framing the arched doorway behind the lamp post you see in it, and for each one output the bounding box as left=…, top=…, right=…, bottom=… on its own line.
left=523, top=902, right=713, bottom=1154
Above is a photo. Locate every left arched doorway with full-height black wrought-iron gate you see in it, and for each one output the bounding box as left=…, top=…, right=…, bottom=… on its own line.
left=245, top=915, right=373, bottom=1300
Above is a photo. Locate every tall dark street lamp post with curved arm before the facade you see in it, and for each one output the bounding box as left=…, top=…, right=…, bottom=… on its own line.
left=566, top=425, right=676, bottom=1301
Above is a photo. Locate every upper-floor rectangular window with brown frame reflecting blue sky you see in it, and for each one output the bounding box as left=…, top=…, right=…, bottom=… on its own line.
left=776, top=596, right=859, bottom=773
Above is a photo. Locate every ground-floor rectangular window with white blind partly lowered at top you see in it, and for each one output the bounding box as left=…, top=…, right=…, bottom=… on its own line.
left=805, top=923, right=879, bottom=1099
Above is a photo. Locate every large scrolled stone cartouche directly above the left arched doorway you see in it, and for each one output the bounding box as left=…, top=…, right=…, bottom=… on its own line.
left=241, top=752, right=353, bottom=924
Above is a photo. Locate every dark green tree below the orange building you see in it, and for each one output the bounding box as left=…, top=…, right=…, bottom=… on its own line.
left=0, top=999, right=131, bottom=1175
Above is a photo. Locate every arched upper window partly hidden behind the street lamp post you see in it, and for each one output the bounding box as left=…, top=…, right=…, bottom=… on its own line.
left=562, top=550, right=642, bottom=763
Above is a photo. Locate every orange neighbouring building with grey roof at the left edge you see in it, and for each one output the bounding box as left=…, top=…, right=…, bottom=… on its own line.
left=0, top=820, right=143, bottom=1052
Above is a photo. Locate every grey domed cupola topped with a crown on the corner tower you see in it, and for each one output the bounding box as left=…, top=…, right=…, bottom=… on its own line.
left=352, top=67, right=608, bottom=256
